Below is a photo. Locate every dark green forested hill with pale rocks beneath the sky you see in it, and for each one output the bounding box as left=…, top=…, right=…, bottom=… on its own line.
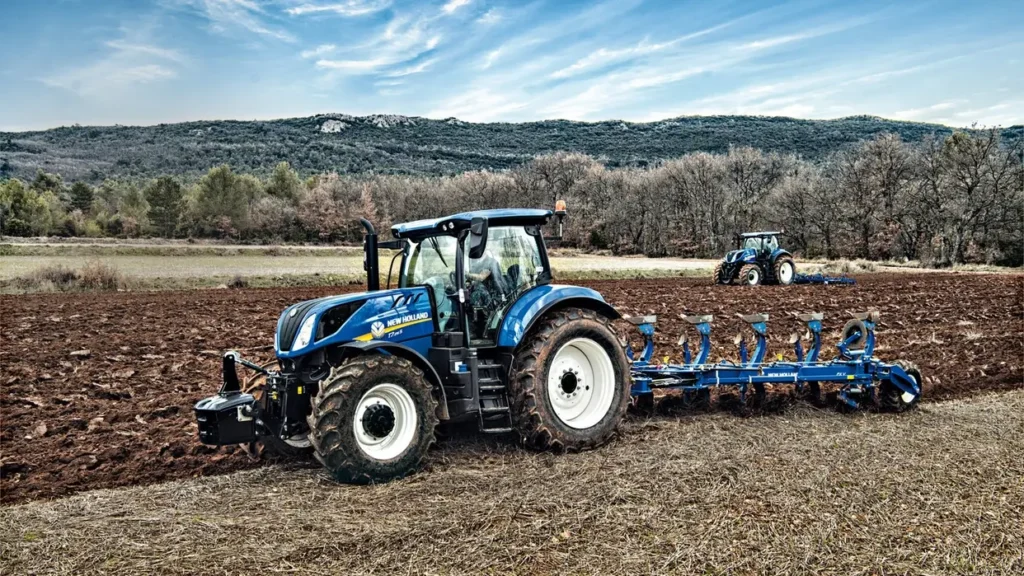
left=0, top=114, right=1024, bottom=182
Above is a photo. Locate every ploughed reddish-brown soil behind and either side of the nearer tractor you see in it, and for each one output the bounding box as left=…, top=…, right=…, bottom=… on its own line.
left=0, top=273, right=1024, bottom=503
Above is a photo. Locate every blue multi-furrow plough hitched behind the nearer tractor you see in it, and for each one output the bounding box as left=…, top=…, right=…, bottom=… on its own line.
left=626, top=311, right=922, bottom=411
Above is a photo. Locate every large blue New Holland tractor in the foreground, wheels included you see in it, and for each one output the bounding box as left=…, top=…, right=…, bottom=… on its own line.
left=196, top=203, right=631, bottom=483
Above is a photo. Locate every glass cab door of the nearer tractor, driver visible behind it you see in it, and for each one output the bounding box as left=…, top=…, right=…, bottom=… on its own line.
left=465, top=227, right=550, bottom=346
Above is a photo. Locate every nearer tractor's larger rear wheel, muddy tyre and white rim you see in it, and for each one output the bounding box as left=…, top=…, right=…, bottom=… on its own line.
left=509, top=308, right=631, bottom=452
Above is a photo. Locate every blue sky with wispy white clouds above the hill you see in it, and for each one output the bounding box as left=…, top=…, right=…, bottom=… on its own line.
left=0, top=0, right=1024, bottom=130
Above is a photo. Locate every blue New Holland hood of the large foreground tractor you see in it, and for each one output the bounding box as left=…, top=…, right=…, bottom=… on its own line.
left=274, top=286, right=433, bottom=358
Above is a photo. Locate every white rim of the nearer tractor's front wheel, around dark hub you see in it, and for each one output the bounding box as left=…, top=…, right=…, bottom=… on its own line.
left=352, top=383, right=417, bottom=460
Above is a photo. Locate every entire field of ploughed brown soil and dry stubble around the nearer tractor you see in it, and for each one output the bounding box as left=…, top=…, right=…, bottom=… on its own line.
left=0, top=273, right=1024, bottom=574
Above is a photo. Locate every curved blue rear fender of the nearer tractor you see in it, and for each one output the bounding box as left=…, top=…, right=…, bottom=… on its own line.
left=498, top=284, right=622, bottom=348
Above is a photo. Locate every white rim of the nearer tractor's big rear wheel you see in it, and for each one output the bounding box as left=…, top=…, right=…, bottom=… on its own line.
left=548, top=338, right=615, bottom=429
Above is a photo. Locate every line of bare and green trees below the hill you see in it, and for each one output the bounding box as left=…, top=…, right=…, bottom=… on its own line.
left=0, top=130, right=1024, bottom=265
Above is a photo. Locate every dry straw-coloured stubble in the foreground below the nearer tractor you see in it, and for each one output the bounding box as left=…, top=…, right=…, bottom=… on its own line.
left=0, top=392, right=1024, bottom=575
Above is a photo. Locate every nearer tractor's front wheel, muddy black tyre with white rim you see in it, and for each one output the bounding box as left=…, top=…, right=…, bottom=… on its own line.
left=309, top=355, right=437, bottom=484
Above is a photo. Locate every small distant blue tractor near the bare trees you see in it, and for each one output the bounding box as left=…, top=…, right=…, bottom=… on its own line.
left=714, top=232, right=797, bottom=286
